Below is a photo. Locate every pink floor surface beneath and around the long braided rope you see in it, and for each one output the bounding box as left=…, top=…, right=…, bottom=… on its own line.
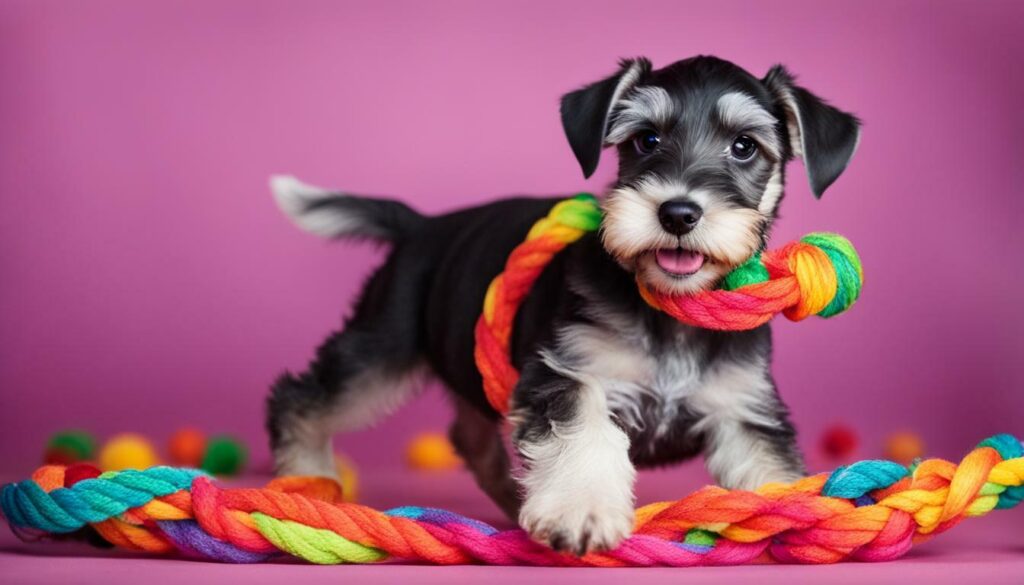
left=0, top=465, right=1024, bottom=585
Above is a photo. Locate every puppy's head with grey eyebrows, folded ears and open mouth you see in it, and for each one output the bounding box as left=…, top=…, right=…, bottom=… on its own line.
left=561, top=56, right=859, bottom=294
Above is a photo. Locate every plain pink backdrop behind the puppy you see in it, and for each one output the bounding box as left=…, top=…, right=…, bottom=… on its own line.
left=0, top=0, right=1024, bottom=471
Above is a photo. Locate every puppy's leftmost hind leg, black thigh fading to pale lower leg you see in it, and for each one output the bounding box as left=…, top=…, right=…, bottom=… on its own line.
left=266, top=257, right=427, bottom=477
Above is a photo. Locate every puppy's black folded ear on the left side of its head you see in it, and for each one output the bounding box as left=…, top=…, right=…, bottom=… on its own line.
left=561, top=57, right=650, bottom=178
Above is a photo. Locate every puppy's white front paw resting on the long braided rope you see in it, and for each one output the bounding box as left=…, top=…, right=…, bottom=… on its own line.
left=519, top=488, right=634, bottom=556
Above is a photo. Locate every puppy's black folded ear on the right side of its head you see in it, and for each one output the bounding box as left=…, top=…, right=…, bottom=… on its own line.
left=762, top=65, right=860, bottom=198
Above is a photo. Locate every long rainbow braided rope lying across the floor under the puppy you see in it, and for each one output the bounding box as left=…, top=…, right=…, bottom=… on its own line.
left=0, top=434, right=1024, bottom=567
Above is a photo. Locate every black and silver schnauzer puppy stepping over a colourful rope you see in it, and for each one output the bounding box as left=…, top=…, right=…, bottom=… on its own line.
left=267, top=56, right=859, bottom=553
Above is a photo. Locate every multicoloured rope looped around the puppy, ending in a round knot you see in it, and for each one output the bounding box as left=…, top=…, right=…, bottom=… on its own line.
left=474, top=193, right=864, bottom=414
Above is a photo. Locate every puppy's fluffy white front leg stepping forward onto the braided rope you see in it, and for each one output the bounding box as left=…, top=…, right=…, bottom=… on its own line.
left=510, top=360, right=636, bottom=554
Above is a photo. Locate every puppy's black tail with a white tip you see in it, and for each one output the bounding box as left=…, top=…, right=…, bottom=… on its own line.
left=270, top=175, right=426, bottom=242
